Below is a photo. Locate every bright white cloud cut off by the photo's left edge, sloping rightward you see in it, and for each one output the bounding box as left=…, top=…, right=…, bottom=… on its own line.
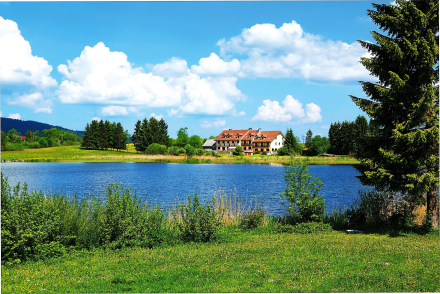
left=0, top=16, right=57, bottom=88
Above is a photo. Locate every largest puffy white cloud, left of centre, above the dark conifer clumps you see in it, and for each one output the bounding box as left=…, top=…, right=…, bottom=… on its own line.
left=58, top=42, right=243, bottom=115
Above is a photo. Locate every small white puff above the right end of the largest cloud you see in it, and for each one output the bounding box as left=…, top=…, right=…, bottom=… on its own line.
left=191, top=53, right=240, bottom=76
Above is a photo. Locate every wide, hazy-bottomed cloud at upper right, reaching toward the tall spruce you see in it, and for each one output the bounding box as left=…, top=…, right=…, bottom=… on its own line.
left=217, top=21, right=369, bottom=81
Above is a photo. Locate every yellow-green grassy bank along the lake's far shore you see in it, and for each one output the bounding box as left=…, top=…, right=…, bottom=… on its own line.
left=1, top=146, right=359, bottom=164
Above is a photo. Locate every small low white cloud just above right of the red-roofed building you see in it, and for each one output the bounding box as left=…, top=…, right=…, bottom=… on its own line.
left=252, top=95, right=322, bottom=124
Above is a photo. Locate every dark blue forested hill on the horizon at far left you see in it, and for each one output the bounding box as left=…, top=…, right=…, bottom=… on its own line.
left=1, top=117, right=83, bottom=137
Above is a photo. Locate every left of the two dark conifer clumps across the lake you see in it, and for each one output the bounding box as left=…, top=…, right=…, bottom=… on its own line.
left=81, top=120, right=130, bottom=151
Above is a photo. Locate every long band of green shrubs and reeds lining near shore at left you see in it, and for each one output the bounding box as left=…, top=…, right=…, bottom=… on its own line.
left=1, top=174, right=272, bottom=263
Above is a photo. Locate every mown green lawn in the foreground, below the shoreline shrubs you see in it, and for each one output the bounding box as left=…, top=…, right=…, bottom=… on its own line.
left=1, top=228, right=440, bottom=293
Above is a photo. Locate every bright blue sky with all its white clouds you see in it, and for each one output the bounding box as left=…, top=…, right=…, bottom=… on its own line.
left=0, top=1, right=389, bottom=139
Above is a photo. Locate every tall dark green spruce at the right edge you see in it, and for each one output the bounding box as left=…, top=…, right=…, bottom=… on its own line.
left=350, top=0, right=439, bottom=227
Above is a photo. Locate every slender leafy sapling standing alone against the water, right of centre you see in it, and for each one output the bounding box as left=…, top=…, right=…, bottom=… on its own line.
left=281, top=157, right=326, bottom=222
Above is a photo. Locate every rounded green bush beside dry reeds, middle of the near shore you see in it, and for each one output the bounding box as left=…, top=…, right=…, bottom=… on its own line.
left=179, top=194, right=221, bottom=242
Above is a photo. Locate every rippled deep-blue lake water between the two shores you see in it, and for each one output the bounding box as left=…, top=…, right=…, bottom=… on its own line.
left=1, top=162, right=365, bottom=215
